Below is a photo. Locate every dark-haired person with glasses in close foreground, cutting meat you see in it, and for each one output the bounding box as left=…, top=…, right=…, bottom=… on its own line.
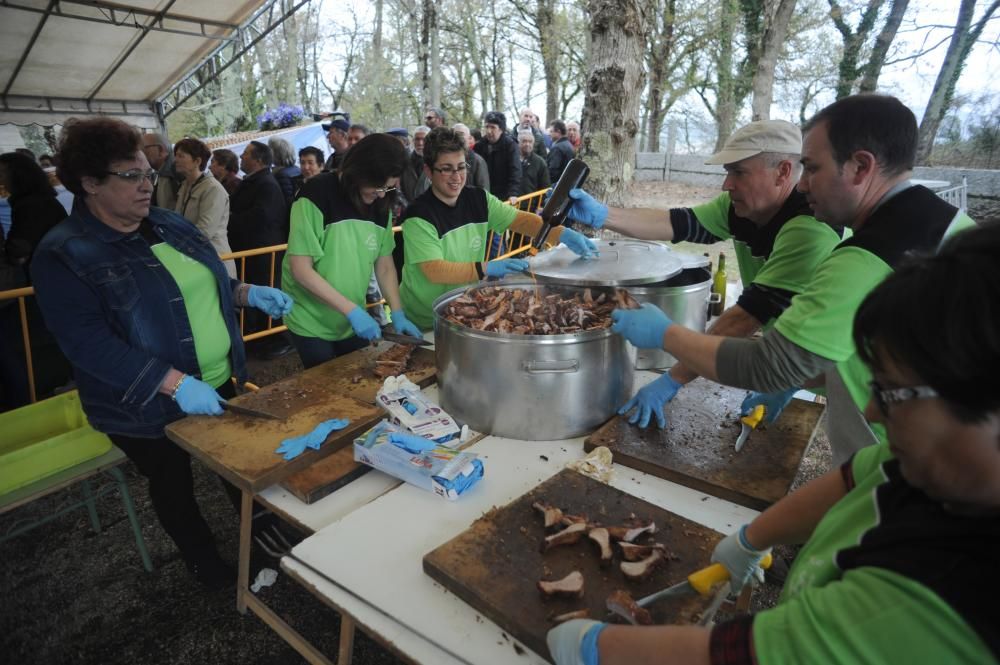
left=548, top=224, right=1000, bottom=665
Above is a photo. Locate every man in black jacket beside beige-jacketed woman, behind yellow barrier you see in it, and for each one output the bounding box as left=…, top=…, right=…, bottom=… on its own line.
left=229, top=141, right=292, bottom=358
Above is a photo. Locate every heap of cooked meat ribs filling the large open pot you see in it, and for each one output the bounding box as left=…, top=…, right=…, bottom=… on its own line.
left=442, top=286, right=639, bottom=335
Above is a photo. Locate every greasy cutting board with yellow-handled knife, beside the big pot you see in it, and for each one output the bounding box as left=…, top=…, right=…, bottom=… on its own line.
left=584, top=379, right=824, bottom=510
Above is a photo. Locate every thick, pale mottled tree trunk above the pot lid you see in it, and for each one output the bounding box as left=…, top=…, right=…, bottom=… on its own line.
left=580, top=0, right=647, bottom=205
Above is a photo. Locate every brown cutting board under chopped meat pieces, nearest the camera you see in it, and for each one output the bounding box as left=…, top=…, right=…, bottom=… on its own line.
left=423, top=469, right=722, bottom=656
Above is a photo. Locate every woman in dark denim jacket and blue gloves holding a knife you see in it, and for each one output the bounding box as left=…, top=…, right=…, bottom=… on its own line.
left=32, top=117, right=292, bottom=588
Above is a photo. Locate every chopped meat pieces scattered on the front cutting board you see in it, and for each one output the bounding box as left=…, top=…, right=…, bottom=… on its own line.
left=532, top=501, right=674, bottom=624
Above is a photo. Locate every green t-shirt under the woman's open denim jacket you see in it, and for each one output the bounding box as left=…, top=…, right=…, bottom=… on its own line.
left=151, top=242, right=232, bottom=388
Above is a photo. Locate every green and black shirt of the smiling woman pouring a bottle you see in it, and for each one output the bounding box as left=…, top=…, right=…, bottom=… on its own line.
left=399, top=187, right=517, bottom=330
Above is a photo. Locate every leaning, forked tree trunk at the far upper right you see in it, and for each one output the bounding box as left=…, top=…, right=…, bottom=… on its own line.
left=916, top=0, right=1000, bottom=164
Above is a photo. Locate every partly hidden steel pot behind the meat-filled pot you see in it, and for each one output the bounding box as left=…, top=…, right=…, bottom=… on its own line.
left=627, top=267, right=712, bottom=369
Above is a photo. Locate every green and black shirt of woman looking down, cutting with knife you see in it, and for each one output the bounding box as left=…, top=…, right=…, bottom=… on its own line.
left=281, top=173, right=396, bottom=341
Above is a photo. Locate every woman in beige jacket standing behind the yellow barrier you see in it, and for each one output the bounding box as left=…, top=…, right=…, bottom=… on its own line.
left=174, top=138, right=236, bottom=277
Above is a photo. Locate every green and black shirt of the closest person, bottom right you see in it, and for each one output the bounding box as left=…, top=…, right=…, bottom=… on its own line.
left=752, top=444, right=997, bottom=665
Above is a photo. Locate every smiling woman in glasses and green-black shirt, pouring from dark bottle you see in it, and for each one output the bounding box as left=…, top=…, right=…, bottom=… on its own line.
left=402, top=127, right=597, bottom=330
